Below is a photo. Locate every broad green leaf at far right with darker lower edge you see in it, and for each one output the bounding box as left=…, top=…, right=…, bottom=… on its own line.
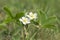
left=43, top=16, right=57, bottom=28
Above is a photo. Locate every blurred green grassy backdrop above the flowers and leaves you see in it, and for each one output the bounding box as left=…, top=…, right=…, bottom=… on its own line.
left=0, top=0, right=60, bottom=17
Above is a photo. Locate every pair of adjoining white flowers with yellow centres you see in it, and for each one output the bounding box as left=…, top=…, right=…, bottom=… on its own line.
left=19, top=12, right=37, bottom=25
